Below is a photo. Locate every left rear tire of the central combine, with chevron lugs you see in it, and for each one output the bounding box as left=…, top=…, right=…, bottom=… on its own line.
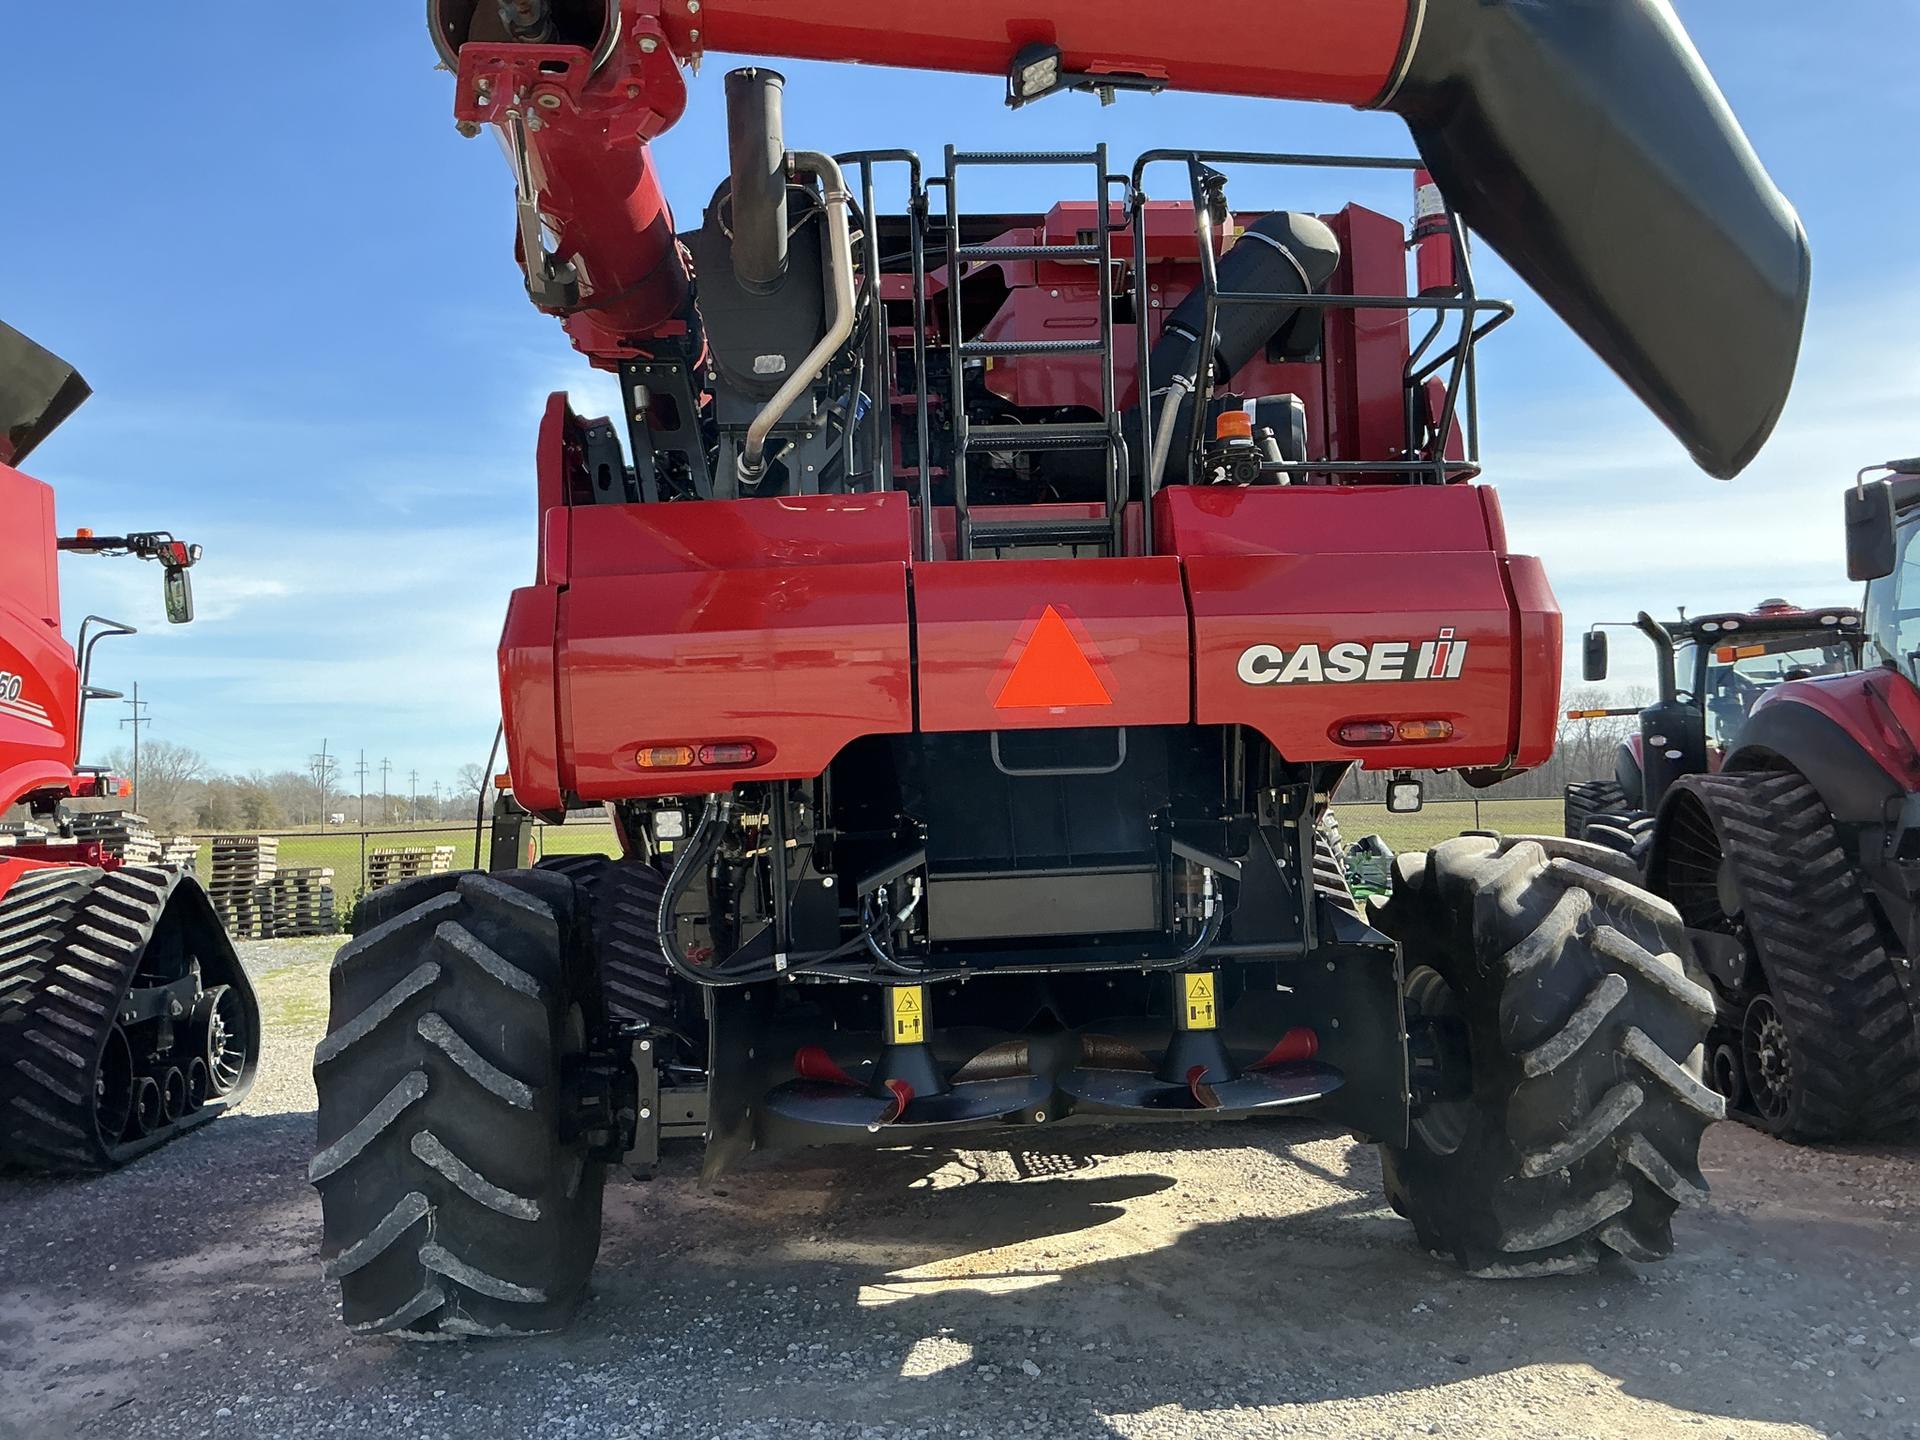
left=307, top=870, right=603, bottom=1338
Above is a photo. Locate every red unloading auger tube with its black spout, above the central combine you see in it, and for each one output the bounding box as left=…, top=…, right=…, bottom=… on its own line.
left=428, top=0, right=1811, bottom=478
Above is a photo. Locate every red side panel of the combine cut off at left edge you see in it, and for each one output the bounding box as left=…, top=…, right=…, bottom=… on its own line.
left=0, top=465, right=81, bottom=810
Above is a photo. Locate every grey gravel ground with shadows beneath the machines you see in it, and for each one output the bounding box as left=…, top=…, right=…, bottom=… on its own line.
left=0, top=943, right=1920, bottom=1440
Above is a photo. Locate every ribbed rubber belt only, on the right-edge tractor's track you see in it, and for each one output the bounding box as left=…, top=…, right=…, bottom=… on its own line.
left=1682, top=774, right=1920, bottom=1140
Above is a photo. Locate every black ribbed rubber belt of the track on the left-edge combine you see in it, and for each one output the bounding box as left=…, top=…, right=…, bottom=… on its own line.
left=0, top=866, right=244, bottom=1173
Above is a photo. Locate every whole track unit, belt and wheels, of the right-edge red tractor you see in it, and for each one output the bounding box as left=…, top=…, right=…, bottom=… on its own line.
left=1651, top=774, right=1920, bottom=1140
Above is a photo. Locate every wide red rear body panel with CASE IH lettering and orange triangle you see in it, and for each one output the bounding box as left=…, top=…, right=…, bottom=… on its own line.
left=501, top=407, right=1561, bottom=810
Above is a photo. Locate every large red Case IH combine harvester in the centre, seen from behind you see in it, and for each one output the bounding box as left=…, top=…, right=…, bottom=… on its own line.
left=311, top=0, right=1807, bottom=1334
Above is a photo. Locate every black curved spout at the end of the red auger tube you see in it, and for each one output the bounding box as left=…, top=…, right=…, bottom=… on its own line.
left=1379, top=0, right=1811, bottom=480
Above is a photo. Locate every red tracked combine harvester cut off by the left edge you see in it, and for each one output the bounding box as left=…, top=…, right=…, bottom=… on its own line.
left=0, top=324, right=259, bottom=1171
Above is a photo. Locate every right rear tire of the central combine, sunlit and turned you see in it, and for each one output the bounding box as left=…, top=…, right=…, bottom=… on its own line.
left=1377, top=835, right=1724, bottom=1279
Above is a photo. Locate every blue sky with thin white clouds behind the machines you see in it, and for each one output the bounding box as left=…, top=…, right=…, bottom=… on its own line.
left=0, top=0, right=1920, bottom=787
